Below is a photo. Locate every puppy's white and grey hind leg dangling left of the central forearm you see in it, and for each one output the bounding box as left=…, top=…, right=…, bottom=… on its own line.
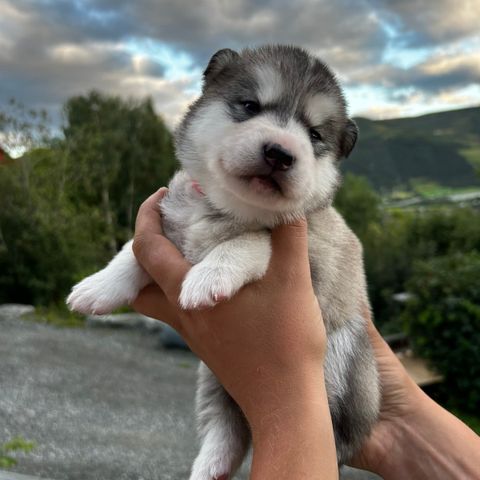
left=190, top=363, right=250, bottom=480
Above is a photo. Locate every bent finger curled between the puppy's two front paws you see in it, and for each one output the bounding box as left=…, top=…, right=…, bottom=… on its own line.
left=133, top=188, right=191, bottom=305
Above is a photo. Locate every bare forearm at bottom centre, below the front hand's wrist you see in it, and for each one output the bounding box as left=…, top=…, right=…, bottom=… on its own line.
left=250, top=373, right=338, bottom=480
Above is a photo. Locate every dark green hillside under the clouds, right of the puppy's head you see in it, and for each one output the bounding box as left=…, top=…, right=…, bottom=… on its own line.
left=343, top=107, right=480, bottom=192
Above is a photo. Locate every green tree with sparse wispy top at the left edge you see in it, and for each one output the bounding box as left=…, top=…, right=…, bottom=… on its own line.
left=0, top=100, right=80, bottom=303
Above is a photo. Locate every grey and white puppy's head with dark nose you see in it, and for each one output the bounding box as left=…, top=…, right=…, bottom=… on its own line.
left=176, top=46, right=357, bottom=224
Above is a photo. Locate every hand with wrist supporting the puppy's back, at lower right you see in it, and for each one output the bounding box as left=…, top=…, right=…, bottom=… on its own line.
left=352, top=307, right=480, bottom=480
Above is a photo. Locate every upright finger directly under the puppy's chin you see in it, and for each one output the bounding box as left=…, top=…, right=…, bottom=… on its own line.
left=267, top=219, right=310, bottom=279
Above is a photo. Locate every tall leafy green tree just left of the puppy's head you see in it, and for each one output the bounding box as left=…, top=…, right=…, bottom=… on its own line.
left=64, top=91, right=177, bottom=253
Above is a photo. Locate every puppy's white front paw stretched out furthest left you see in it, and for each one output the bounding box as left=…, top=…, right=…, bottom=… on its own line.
left=67, top=270, right=135, bottom=315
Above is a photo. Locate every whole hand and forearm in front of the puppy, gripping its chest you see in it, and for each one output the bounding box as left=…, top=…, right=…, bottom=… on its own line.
left=133, top=189, right=338, bottom=480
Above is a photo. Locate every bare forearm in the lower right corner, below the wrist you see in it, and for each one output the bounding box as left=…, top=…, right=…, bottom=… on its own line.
left=374, top=392, right=480, bottom=480
